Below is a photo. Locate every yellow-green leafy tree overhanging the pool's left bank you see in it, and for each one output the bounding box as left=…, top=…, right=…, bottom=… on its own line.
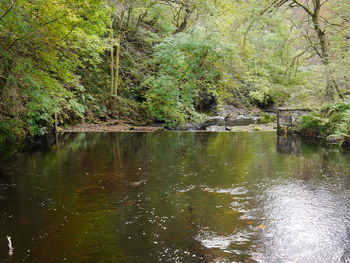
left=0, top=0, right=108, bottom=135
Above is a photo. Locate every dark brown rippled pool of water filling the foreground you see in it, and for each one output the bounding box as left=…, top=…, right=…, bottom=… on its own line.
left=0, top=132, right=350, bottom=263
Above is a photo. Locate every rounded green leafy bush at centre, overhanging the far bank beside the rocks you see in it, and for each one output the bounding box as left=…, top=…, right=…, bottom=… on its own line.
left=144, top=28, right=223, bottom=125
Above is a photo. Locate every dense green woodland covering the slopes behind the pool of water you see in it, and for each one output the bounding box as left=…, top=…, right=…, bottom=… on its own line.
left=0, top=0, right=350, bottom=144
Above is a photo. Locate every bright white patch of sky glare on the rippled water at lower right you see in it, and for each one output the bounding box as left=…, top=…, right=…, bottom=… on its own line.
left=254, top=180, right=350, bottom=262
